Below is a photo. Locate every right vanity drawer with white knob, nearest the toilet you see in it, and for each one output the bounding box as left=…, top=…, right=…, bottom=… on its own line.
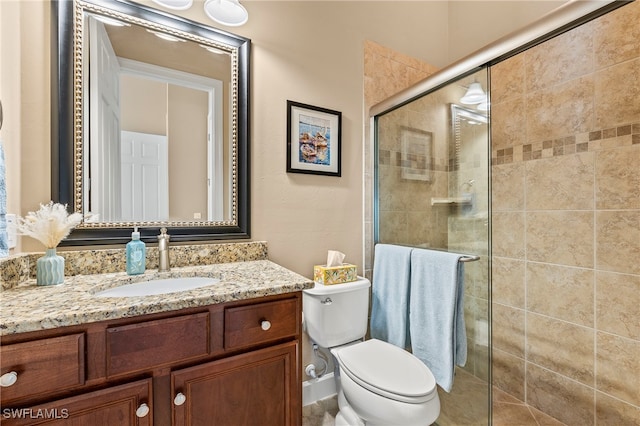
left=224, top=299, right=300, bottom=349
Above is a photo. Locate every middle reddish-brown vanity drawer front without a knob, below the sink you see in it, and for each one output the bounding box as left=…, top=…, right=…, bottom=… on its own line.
left=106, top=312, right=209, bottom=376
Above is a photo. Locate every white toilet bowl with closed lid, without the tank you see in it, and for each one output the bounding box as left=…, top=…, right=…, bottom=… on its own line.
left=331, top=339, right=440, bottom=426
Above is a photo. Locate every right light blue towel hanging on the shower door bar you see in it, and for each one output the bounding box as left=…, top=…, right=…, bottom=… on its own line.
left=409, top=249, right=467, bottom=392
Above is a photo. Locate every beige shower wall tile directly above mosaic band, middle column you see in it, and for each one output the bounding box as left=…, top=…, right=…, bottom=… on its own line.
left=524, top=76, right=594, bottom=141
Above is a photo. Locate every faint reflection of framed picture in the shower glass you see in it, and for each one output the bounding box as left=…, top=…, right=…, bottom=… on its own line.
left=400, top=126, right=433, bottom=182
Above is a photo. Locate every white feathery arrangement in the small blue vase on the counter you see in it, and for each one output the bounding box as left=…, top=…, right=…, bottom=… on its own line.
left=17, top=201, right=83, bottom=249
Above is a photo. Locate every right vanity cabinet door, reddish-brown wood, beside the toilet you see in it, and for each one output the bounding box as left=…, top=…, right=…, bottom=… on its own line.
left=171, top=341, right=301, bottom=426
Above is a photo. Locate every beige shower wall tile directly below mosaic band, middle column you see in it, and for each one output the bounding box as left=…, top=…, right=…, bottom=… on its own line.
left=526, top=152, right=594, bottom=210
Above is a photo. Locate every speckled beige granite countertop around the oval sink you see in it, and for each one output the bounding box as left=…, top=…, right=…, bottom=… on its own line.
left=0, top=260, right=314, bottom=336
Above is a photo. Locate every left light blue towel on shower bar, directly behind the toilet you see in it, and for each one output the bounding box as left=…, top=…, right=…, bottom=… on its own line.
left=371, top=244, right=412, bottom=349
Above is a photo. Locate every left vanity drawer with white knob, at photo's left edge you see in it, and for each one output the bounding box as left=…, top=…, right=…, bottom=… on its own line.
left=0, top=333, right=85, bottom=405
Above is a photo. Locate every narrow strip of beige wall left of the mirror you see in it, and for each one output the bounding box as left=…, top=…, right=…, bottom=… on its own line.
left=0, top=1, right=51, bottom=252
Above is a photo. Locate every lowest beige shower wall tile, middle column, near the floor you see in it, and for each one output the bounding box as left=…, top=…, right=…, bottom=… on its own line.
left=527, top=363, right=595, bottom=426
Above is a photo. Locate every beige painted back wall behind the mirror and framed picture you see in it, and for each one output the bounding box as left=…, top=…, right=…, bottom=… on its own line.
left=0, top=1, right=568, bottom=276
